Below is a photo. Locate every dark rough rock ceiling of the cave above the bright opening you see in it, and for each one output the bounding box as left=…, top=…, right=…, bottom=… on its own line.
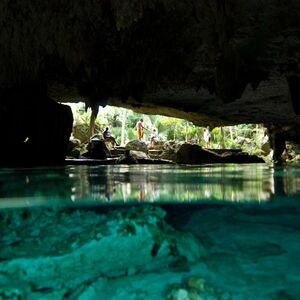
left=0, top=0, right=300, bottom=164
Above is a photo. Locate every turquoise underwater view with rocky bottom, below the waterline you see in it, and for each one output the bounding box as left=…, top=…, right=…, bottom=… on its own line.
left=0, top=204, right=300, bottom=300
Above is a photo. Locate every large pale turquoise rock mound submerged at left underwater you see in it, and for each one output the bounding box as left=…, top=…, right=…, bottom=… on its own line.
left=0, top=207, right=203, bottom=299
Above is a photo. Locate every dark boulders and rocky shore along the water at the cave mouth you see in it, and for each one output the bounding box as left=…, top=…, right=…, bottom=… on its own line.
left=66, top=139, right=265, bottom=165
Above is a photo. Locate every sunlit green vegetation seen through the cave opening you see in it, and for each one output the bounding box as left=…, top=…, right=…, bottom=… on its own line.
left=69, top=102, right=272, bottom=160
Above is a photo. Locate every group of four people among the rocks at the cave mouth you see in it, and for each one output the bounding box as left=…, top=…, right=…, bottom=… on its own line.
left=102, top=119, right=211, bottom=149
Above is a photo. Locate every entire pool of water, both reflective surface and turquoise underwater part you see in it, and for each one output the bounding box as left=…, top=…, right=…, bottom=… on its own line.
left=0, top=164, right=300, bottom=300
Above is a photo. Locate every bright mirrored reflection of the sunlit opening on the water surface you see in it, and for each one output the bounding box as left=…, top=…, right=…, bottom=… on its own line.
left=69, top=165, right=300, bottom=202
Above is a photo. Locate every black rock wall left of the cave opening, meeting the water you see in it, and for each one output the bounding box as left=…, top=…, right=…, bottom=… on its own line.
left=0, top=89, right=73, bottom=167
